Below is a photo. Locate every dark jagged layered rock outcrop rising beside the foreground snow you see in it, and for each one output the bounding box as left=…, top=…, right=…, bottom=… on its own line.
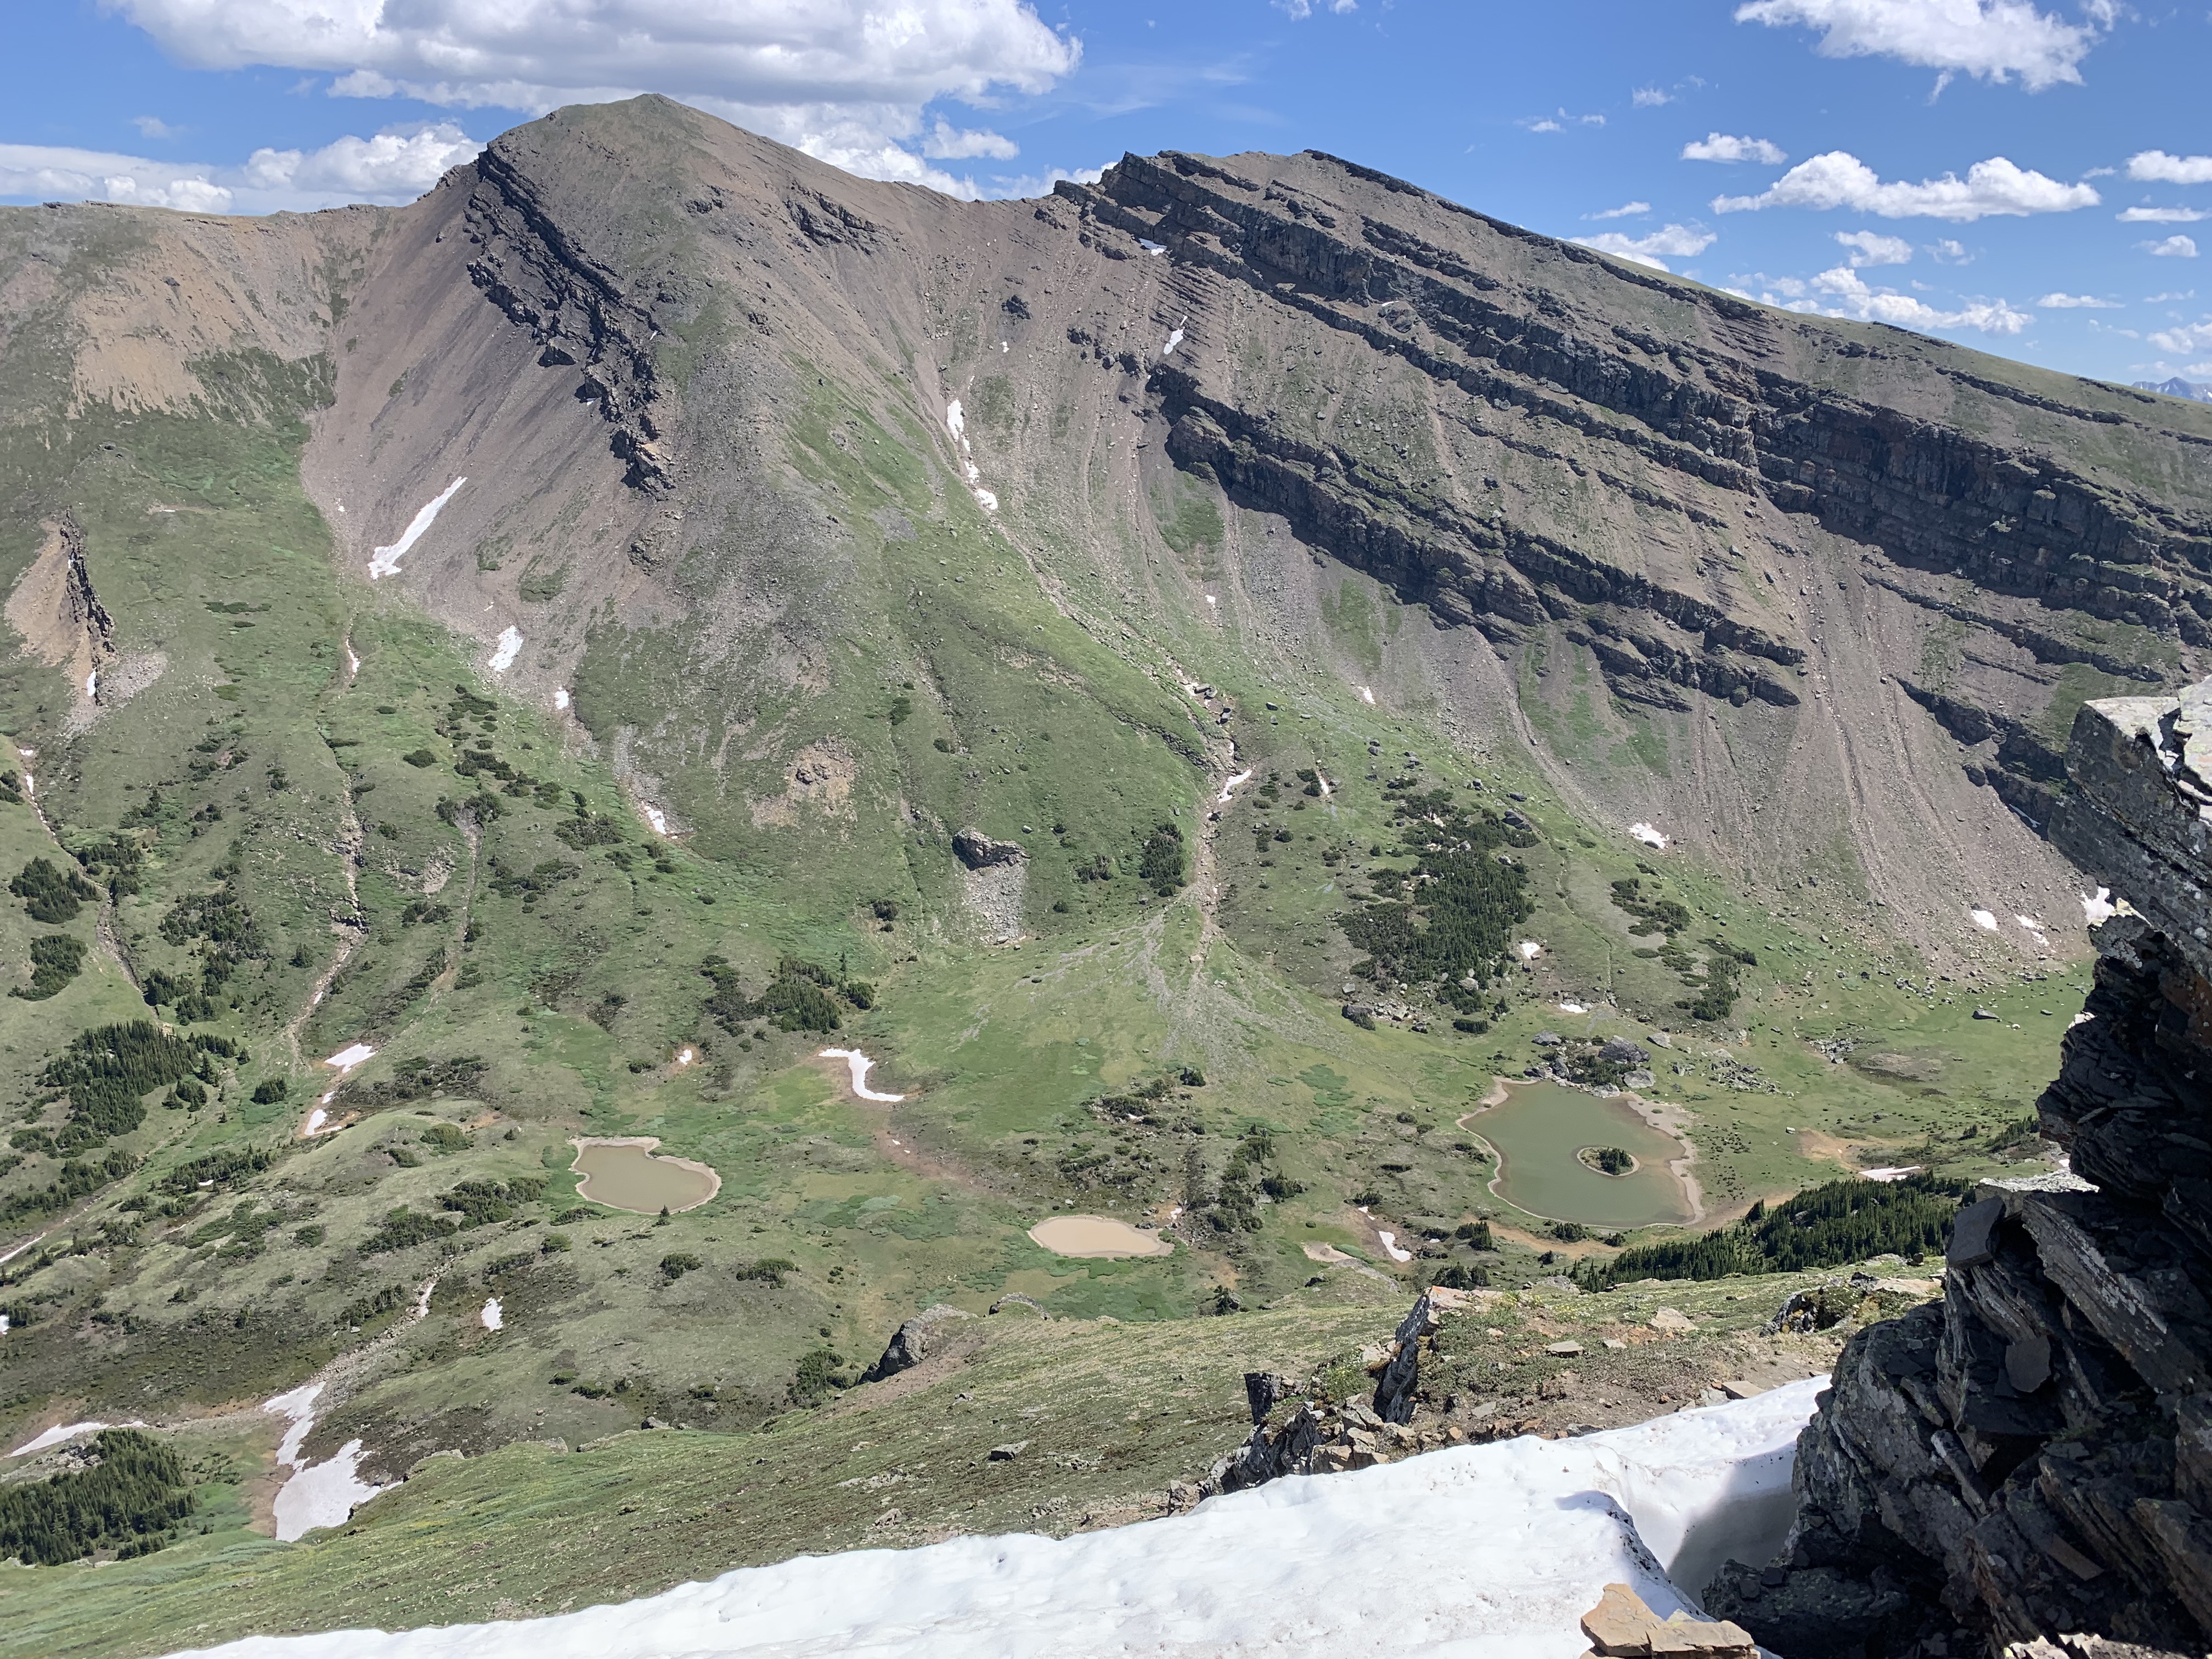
left=1708, top=681, right=2212, bottom=1659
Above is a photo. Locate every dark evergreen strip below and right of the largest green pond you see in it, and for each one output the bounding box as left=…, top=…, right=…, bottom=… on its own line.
left=1575, top=1175, right=1968, bottom=1290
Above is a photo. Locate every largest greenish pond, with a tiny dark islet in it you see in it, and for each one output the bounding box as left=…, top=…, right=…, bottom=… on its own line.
left=1466, top=1082, right=1695, bottom=1228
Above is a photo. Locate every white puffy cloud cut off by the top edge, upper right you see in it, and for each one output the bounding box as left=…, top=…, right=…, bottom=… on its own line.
left=1736, top=0, right=2113, bottom=93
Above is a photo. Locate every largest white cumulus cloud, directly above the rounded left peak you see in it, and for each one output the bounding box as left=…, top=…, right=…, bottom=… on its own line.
left=111, top=0, right=1082, bottom=195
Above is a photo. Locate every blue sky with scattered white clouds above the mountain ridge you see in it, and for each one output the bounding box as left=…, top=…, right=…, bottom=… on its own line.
left=0, top=0, right=2212, bottom=381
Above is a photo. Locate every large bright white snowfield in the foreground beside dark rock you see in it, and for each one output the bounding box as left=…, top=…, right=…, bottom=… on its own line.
left=160, top=1378, right=1827, bottom=1659
